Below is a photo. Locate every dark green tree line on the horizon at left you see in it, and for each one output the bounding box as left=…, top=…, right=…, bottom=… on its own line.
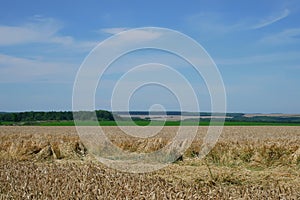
left=0, top=110, right=114, bottom=122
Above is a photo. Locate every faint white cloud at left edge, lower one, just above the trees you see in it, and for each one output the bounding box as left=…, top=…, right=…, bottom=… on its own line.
left=0, top=54, right=76, bottom=83
